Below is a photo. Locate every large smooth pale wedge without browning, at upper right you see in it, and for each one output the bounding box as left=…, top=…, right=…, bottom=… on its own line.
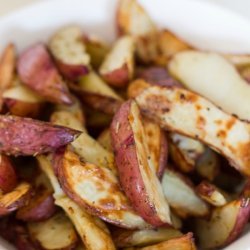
left=168, top=51, right=250, bottom=120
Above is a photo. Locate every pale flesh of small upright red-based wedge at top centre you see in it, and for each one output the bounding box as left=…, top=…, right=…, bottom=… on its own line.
left=100, top=36, right=134, bottom=74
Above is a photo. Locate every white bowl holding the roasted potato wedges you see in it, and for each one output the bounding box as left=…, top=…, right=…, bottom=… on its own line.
left=0, top=0, right=250, bottom=250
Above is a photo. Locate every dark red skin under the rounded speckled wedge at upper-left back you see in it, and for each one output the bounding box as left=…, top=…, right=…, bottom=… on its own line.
left=55, top=59, right=89, bottom=81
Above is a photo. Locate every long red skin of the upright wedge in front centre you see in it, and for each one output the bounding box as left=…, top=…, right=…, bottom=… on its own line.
left=110, top=100, right=165, bottom=227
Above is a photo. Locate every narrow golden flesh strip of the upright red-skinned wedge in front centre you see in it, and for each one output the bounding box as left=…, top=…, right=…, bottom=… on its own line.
left=129, top=102, right=171, bottom=224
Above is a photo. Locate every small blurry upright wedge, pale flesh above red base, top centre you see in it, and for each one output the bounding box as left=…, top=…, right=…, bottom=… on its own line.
left=99, top=36, right=135, bottom=87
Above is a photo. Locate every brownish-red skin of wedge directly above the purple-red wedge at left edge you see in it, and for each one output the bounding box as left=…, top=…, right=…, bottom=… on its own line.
left=4, top=98, right=44, bottom=118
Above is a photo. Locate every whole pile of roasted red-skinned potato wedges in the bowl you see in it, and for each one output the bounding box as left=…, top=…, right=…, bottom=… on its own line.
left=0, top=0, right=250, bottom=250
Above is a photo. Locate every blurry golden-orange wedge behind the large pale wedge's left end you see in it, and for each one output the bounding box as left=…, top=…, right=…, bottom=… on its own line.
left=155, top=29, right=192, bottom=67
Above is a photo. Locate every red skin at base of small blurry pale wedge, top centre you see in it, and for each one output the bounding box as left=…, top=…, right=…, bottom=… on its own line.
left=102, top=63, right=129, bottom=88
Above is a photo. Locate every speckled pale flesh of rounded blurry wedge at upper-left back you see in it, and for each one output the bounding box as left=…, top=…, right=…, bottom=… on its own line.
left=49, top=26, right=90, bottom=65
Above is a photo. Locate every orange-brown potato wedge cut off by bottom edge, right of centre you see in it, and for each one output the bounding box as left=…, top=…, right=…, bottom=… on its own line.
left=135, top=233, right=196, bottom=250
